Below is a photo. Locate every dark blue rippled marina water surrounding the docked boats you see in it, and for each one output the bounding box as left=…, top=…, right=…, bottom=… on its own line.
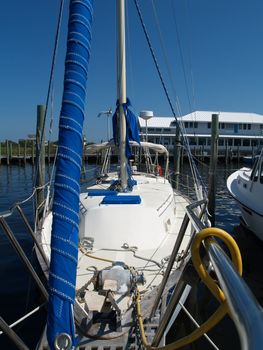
left=0, top=164, right=240, bottom=350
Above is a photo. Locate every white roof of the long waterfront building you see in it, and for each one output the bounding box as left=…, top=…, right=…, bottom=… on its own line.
left=139, top=111, right=263, bottom=128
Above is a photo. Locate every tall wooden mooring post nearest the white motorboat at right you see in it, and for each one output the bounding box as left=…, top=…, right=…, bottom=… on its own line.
left=207, top=114, right=219, bottom=226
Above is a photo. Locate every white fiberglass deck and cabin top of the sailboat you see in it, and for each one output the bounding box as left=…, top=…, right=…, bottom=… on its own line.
left=41, top=174, right=190, bottom=289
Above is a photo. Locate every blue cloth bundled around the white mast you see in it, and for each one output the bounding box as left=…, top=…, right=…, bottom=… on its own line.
left=112, top=98, right=140, bottom=159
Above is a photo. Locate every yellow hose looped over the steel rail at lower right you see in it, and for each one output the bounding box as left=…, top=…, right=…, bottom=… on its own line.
left=136, top=228, right=242, bottom=350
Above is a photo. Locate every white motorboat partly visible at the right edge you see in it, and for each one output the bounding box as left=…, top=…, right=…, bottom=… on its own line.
left=227, top=152, right=263, bottom=240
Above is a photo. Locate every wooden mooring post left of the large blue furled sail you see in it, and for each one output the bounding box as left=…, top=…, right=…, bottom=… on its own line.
left=36, top=105, right=46, bottom=221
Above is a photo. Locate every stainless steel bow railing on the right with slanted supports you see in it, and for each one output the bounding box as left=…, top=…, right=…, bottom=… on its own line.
left=151, top=200, right=263, bottom=350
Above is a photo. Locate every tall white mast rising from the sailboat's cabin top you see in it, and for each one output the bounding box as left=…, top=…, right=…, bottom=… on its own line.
left=117, top=0, right=127, bottom=191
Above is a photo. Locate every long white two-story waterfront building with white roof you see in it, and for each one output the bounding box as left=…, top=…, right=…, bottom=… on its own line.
left=139, top=111, right=263, bottom=153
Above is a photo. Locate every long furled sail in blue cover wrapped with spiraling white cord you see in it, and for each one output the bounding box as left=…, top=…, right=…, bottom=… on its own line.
left=47, top=0, right=93, bottom=349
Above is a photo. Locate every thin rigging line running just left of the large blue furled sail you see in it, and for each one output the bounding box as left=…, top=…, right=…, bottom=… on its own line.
left=34, top=0, right=64, bottom=189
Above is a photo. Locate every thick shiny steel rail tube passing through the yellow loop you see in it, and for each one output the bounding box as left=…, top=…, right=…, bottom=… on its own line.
left=207, top=242, right=263, bottom=350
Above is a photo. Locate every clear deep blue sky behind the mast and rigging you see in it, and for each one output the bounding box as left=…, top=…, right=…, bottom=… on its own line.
left=0, top=0, right=263, bottom=141
